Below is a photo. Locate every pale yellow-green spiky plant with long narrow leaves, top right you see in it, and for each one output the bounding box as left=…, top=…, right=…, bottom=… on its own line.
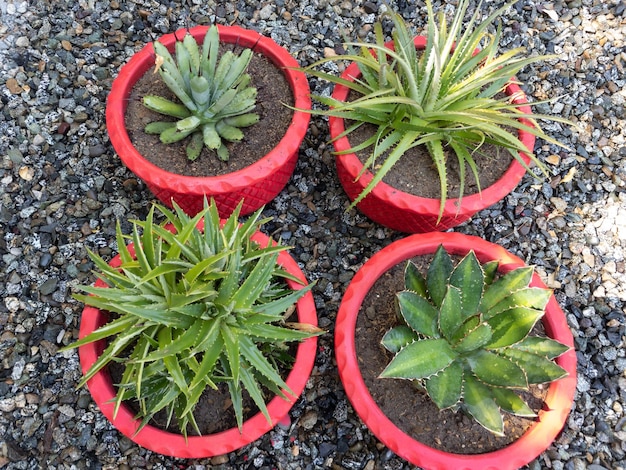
left=304, top=0, right=567, bottom=217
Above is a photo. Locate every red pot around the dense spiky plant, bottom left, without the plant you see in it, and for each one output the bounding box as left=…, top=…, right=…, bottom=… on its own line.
left=78, top=232, right=317, bottom=458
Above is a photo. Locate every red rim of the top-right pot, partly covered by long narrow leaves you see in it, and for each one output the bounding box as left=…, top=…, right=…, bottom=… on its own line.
left=328, top=36, right=535, bottom=221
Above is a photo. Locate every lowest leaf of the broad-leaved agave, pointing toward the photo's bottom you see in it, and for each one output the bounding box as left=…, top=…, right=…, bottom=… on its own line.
left=463, top=373, right=504, bottom=436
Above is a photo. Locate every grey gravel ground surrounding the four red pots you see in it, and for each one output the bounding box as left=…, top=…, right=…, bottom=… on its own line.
left=0, top=0, right=626, bottom=470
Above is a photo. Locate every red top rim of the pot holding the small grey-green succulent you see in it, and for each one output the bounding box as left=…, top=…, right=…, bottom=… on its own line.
left=106, top=25, right=311, bottom=196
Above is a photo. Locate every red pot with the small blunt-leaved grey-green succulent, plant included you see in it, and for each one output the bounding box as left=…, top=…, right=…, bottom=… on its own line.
left=106, top=25, right=311, bottom=217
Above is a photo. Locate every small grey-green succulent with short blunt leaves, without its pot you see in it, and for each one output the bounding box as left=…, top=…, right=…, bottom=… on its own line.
left=143, top=26, right=259, bottom=160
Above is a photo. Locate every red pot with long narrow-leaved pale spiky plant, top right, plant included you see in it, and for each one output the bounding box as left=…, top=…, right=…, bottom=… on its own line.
left=304, top=0, right=566, bottom=232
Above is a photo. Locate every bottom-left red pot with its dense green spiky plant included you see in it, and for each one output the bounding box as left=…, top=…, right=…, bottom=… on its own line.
left=61, top=203, right=320, bottom=458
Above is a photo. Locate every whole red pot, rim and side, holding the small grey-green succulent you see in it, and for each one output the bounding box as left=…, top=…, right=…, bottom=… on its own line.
left=106, top=25, right=311, bottom=218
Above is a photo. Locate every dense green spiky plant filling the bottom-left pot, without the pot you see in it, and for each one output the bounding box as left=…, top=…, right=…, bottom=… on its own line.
left=63, top=199, right=320, bottom=436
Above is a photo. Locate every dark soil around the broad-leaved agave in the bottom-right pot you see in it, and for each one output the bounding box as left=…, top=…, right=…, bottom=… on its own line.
left=355, top=256, right=548, bottom=454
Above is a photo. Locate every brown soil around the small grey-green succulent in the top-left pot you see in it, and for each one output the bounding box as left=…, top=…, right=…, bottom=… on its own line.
left=125, top=45, right=294, bottom=176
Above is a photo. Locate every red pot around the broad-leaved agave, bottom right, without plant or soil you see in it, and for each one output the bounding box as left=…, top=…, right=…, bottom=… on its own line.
left=335, top=232, right=576, bottom=470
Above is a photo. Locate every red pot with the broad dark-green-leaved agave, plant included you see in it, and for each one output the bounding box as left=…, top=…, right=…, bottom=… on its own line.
left=335, top=232, right=576, bottom=470
